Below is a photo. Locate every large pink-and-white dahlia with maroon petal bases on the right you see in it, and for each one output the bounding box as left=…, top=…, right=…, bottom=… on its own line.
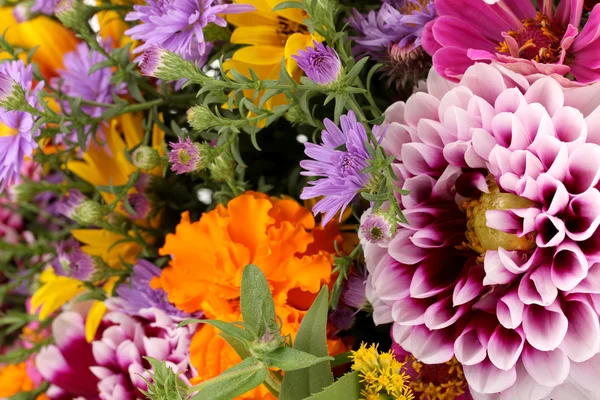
left=365, top=63, right=600, bottom=400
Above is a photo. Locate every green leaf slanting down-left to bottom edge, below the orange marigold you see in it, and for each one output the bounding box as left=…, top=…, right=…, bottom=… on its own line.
left=191, top=358, right=268, bottom=400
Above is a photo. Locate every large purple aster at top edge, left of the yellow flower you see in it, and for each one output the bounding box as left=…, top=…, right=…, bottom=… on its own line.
left=125, top=0, right=255, bottom=61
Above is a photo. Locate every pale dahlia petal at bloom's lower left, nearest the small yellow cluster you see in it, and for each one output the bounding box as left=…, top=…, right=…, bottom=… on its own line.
left=402, top=325, right=454, bottom=364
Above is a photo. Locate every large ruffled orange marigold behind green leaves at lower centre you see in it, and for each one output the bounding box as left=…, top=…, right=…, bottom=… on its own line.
left=153, top=192, right=345, bottom=399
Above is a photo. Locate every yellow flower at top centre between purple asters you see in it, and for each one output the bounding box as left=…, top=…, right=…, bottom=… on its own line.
left=223, top=0, right=322, bottom=110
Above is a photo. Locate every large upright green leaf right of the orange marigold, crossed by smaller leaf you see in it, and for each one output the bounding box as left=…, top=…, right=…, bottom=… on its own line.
left=279, top=286, right=333, bottom=400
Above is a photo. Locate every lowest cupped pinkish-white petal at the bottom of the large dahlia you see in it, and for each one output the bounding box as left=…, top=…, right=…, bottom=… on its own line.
left=463, top=360, right=517, bottom=394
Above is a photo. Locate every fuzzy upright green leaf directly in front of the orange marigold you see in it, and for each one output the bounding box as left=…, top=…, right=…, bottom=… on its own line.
left=240, top=264, right=279, bottom=338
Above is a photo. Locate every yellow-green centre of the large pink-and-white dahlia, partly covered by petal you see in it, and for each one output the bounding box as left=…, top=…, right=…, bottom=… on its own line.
left=464, top=185, right=535, bottom=254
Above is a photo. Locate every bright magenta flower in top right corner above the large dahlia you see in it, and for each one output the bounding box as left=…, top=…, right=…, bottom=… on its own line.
left=423, top=0, right=600, bottom=83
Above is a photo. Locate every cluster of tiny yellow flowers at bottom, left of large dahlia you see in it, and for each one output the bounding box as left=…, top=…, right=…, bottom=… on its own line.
left=351, top=343, right=415, bottom=400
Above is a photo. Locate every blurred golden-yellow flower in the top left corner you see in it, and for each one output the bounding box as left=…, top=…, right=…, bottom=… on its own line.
left=0, top=7, right=77, bottom=78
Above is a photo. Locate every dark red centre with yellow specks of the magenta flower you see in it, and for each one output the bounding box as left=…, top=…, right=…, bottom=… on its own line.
left=496, top=13, right=565, bottom=63
